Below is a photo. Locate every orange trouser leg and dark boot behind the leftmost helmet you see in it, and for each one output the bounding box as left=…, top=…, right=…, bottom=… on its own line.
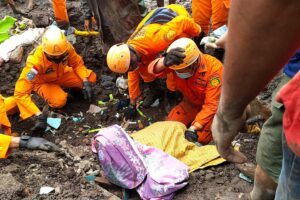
left=52, top=0, right=70, bottom=30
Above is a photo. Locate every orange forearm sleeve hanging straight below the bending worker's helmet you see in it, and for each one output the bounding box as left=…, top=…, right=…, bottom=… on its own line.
left=128, top=70, right=141, bottom=100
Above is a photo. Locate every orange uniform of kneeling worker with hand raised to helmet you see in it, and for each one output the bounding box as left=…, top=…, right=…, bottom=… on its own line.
left=149, top=54, right=223, bottom=144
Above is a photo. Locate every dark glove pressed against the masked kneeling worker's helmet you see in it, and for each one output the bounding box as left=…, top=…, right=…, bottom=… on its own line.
left=164, top=47, right=185, bottom=67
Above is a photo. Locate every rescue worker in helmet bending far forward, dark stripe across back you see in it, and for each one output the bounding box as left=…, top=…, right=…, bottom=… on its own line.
left=107, top=4, right=201, bottom=118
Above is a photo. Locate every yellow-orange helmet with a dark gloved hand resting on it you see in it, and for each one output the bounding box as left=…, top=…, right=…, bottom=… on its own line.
left=167, top=38, right=200, bottom=70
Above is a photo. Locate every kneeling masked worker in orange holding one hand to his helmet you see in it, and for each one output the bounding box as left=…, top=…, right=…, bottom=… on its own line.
left=149, top=38, right=223, bottom=144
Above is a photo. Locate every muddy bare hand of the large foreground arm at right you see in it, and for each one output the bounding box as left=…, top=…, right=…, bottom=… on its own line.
left=212, top=109, right=247, bottom=163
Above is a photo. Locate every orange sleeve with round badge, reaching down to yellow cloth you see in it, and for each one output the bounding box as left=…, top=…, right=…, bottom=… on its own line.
left=193, top=58, right=222, bottom=126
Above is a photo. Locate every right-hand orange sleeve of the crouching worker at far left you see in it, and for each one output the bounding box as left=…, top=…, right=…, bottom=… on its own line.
left=68, top=44, right=92, bottom=80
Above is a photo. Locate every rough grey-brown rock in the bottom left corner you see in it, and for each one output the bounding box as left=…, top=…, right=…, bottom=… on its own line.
left=0, top=173, right=26, bottom=199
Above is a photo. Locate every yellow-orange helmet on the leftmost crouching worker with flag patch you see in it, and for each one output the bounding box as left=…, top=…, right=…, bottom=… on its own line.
left=42, top=26, right=69, bottom=56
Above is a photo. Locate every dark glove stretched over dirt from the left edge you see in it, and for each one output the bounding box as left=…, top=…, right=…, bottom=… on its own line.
left=20, top=135, right=60, bottom=151
